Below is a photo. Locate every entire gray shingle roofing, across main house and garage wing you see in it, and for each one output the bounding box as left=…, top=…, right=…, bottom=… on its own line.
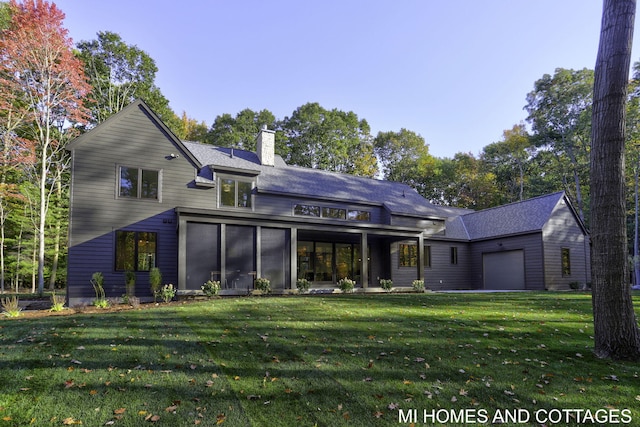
left=183, top=141, right=564, bottom=240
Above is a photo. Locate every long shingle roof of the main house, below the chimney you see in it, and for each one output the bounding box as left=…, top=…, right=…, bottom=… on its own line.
left=184, top=142, right=469, bottom=218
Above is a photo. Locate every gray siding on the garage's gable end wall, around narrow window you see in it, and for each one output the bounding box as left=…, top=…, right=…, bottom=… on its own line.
left=543, top=202, right=591, bottom=290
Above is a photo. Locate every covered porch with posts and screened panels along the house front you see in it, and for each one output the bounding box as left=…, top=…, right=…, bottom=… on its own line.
left=177, top=209, right=424, bottom=295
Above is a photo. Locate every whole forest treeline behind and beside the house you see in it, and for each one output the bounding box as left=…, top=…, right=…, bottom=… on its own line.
left=0, top=0, right=640, bottom=292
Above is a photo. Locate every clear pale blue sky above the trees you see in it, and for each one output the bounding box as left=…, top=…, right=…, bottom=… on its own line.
left=53, top=0, right=640, bottom=158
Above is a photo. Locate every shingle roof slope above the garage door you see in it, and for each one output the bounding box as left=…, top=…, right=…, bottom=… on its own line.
left=461, top=192, right=564, bottom=240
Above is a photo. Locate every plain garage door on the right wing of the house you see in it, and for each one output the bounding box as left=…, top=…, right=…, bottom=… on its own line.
left=482, top=250, right=524, bottom=290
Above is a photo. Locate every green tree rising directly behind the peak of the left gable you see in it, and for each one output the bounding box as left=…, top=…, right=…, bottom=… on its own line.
left=78, top=31, right=180, bottom=133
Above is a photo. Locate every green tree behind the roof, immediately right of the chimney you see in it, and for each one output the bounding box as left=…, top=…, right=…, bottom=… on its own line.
left=281, top=103, right=377, bottom=177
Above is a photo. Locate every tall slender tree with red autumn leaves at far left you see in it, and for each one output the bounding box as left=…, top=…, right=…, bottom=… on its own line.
left=0, top=0, right=90, bottom=293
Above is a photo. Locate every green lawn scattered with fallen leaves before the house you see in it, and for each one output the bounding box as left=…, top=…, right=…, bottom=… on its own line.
left=0, top=293, right=640, bottom=427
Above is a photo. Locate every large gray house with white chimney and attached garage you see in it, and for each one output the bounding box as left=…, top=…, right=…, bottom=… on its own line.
left=67, top=100, right=590, bottom=305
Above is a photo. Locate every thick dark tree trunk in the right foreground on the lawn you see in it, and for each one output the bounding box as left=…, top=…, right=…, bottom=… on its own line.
left=591, top=0, right=640, bottom=359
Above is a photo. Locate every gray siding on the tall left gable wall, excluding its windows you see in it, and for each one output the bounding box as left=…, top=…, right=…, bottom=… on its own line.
left=67, top=103, right=215, bottom=299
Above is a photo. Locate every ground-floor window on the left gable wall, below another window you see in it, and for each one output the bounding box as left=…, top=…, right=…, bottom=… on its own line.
left=116, top=231, right=158, bottom=271
